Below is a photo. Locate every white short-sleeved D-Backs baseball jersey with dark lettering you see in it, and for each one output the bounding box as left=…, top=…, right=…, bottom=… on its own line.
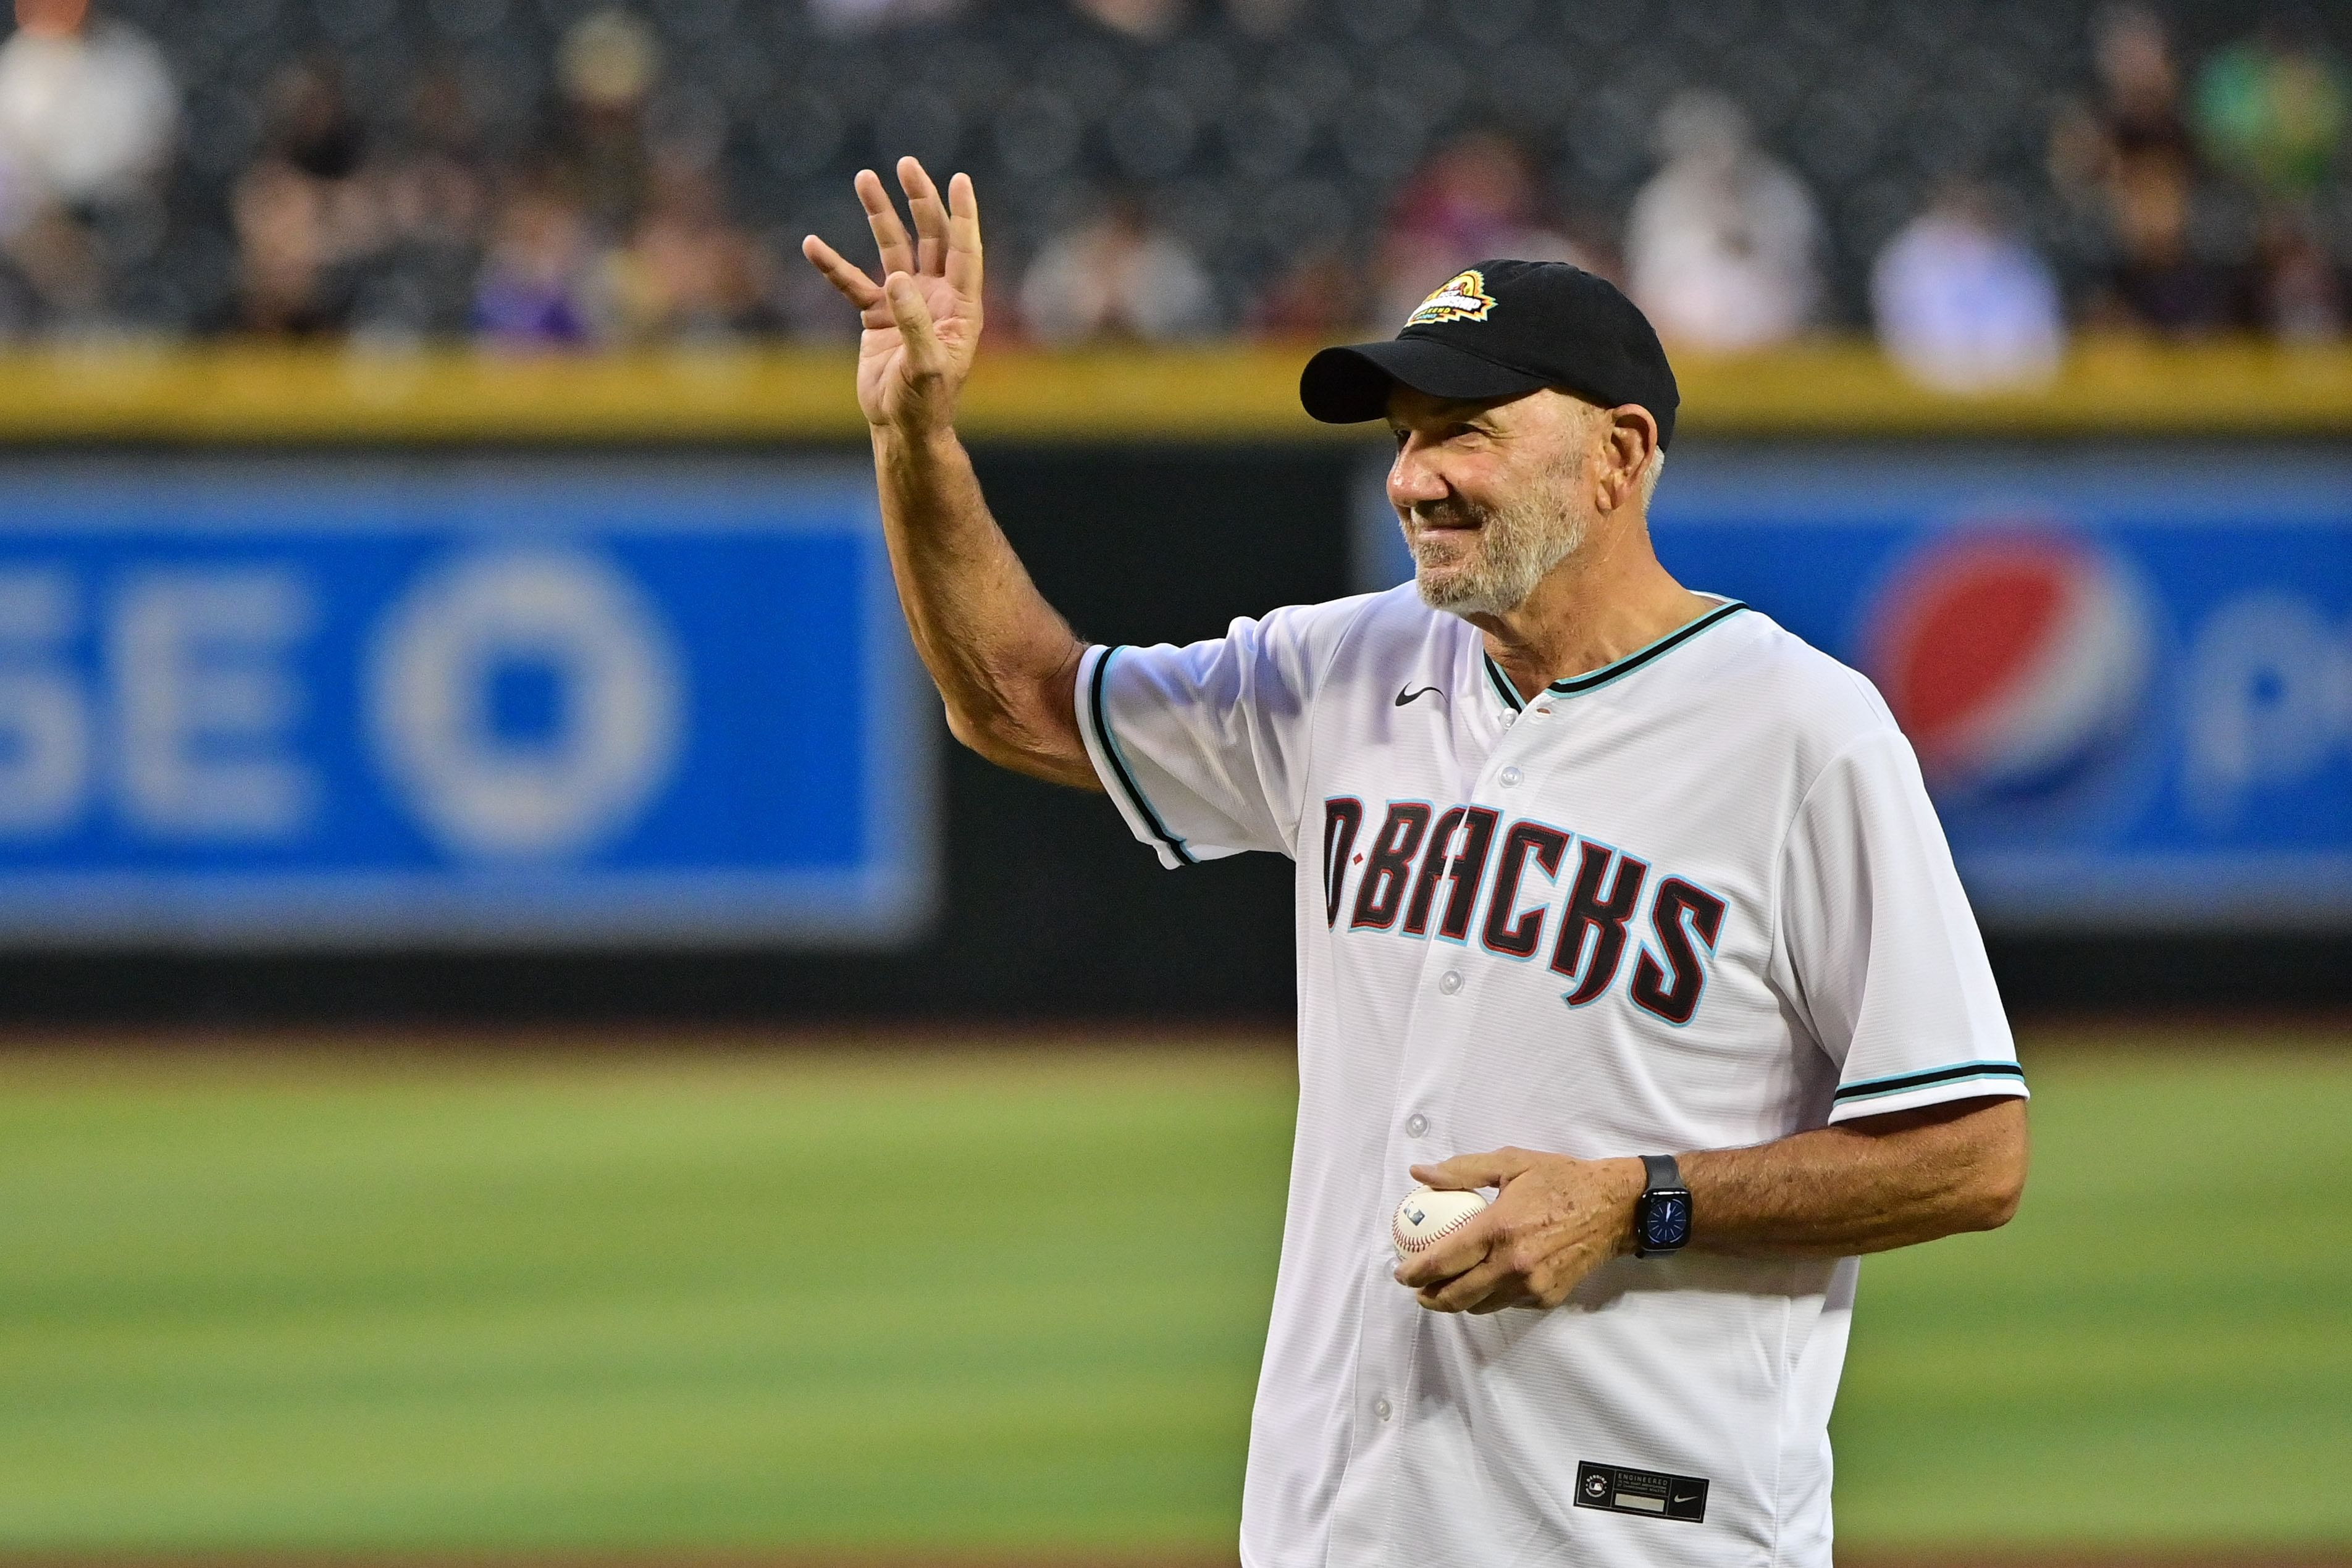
left=1077, top=583, right=2025, bottom=1568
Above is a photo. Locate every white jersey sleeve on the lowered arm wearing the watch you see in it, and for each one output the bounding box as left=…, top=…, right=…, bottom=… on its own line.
left=1773, top=726, right=2025, bottom=1121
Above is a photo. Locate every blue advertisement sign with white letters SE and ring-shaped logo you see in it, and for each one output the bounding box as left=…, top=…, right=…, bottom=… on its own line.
left=0, top=461, right=934, bottom=945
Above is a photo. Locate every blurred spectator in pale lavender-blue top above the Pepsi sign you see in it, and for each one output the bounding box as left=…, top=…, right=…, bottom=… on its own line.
left=1870, top=181, right=2065, bottom=393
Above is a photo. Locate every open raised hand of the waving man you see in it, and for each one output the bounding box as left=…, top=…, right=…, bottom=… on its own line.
left=800, top=157, right=981, bottom=435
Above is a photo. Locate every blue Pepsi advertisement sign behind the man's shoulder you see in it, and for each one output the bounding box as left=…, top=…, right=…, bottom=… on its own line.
left=1359, top=451, right=2352, bottom=926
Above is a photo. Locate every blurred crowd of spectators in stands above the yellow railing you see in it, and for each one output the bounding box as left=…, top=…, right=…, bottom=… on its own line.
left=0, top=0, right=2352, bottom=388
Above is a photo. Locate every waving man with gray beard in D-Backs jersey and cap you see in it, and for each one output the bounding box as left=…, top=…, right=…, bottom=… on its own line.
left=804, top=160, right=2025, bottom=1568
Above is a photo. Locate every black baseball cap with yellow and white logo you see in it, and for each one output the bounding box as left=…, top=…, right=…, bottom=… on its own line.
left=1298, top=261, right=1682, bottom=447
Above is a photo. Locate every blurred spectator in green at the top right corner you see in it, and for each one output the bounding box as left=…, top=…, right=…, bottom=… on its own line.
left=2197, top=17, right=2352, bottom=207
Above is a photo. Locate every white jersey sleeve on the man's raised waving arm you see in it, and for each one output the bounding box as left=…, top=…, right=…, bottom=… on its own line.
left=1077, top=600, right=1354, bottom=868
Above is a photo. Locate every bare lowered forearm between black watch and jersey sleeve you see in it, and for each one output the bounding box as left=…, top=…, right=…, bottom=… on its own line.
left=1679, top=1100, right=2025, bottom=1258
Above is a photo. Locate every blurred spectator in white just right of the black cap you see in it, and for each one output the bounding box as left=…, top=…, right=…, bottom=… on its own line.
left=1625, top=91, right=1820, bottom=353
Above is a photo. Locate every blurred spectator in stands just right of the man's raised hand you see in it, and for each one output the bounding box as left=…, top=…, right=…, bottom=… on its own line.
left=1021, top=198, right=1219, bottom=343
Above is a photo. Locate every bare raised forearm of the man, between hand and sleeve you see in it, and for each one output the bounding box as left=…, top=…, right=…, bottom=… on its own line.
left=873, top=428, right=1098, bottom=787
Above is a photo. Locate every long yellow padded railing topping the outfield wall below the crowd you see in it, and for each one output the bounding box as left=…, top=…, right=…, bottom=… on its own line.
left=0, top=338, right=2352, bottom=444
